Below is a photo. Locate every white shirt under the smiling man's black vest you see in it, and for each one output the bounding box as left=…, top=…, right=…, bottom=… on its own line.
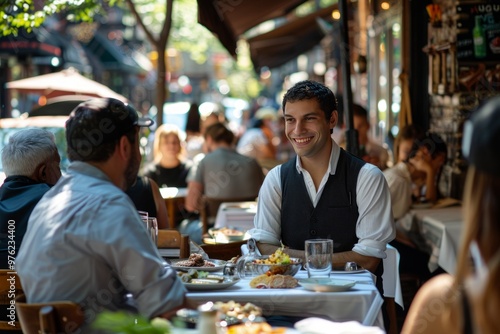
left=249, top=140, right=396, bottom=259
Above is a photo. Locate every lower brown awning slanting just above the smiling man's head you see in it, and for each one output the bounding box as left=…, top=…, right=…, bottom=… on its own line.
left=247, top=4, right=337, bottom=71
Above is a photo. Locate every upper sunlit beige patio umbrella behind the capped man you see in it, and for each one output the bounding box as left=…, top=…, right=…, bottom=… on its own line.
left=7, top=68, right=128, bottom=102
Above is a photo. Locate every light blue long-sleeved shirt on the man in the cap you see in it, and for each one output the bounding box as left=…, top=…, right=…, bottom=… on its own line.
left=16, top=162, right=186, bottom=323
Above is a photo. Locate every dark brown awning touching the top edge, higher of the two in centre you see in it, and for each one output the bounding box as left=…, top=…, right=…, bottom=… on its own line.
left=198, top=0, right=306, bottom=57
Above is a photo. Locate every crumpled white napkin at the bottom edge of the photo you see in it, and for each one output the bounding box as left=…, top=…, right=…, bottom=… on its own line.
left=295, top=318, right=385, bottom=334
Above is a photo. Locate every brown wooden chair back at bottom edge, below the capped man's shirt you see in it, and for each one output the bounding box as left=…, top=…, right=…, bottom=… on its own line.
left=16, top=295, right=85, bottom=334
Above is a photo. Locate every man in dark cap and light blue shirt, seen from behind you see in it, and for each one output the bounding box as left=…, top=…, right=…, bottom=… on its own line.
left=16, top=98, right=186, bottom=324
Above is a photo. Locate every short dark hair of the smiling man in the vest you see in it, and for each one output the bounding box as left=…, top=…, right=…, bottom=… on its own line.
left=282, top=80, right=337, bottom=120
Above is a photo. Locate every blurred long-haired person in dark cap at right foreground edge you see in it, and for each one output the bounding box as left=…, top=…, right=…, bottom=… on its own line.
left=402, top=97, right=500, bottom=333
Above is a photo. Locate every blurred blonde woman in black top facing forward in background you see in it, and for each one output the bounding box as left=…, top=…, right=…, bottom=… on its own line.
left=142, top=124, right=191, bottom=188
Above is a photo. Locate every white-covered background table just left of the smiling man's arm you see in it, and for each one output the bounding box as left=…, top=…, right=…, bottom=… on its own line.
left=214, top=201, right=257, bottom=231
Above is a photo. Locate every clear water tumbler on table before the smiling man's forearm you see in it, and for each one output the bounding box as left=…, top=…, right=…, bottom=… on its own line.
left=305, top=239, right=333, bottom=278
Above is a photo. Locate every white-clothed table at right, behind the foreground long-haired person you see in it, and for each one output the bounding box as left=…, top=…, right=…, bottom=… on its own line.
left=398, top=206, right=463, bottom=274
